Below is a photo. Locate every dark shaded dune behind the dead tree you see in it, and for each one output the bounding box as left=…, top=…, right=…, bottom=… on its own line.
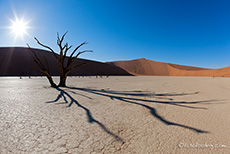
left=0, top=47, right=130, bottom=76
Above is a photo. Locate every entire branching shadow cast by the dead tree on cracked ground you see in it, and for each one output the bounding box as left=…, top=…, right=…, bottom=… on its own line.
left=47, top=87, right=213, bottom=142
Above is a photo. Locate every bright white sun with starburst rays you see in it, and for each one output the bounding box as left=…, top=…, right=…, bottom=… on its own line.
left=9, top=18, right=29, bottom=38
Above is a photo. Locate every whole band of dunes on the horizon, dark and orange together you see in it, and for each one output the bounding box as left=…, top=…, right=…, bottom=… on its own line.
left=0, top=47, right=230, bottom=77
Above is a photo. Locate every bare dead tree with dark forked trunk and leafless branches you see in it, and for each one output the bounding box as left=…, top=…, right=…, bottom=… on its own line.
left=27, top=32, right=93, bottom=87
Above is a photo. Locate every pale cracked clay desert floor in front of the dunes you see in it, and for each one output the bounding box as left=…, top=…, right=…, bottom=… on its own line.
left=0, top=76, right=230, bottom=154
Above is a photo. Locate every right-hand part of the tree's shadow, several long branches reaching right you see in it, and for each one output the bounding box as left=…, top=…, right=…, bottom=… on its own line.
left=67, top=87, right=214, bottom=133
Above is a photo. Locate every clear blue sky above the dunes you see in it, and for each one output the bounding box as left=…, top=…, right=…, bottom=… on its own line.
left=0, top=0, right=230, bottom=68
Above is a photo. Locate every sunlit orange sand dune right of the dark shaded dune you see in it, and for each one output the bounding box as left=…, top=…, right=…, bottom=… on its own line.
left=109, top=58, right=230, bottom=77
